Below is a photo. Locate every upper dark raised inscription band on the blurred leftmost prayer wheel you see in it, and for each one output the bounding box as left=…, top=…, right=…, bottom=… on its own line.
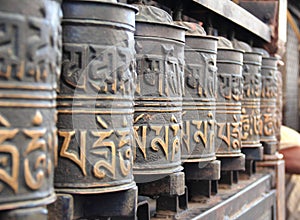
left=0, top=6, right=61, bottom=89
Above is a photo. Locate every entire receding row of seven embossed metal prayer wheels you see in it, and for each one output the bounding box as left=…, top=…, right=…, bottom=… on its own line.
left=0, top=0, right=278, bottom=219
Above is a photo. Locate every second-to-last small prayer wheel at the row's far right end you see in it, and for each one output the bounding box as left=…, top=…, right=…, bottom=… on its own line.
left=241, top=52, right=262, bottom=153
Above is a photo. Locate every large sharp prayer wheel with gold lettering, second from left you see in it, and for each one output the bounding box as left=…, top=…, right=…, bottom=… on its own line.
left=54, top=0, right=137, bottom=194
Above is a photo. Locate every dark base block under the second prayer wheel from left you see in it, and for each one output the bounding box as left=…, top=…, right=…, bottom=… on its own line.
left=50, top=187, right=138, bottom=219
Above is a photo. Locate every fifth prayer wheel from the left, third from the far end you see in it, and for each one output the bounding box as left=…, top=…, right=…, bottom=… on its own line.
left=216, top=48, right=243, bottom=163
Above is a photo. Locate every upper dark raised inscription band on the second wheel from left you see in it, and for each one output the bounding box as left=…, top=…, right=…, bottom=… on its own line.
left=61, top=43, right=134, bottom=96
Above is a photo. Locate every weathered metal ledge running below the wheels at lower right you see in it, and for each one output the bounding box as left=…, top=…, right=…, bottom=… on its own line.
left=151, top=173, right=276, bottom=220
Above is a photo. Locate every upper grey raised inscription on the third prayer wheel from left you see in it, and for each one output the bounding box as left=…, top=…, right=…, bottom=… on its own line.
left=135, top=42, right=183, bottom=97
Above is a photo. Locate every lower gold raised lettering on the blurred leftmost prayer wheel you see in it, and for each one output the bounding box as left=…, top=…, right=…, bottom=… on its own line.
left=0, top=110, right=57, bottom=194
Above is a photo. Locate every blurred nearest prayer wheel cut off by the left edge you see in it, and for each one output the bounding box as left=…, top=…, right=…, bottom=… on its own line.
left=0, top=0, right=61, bottom=211
